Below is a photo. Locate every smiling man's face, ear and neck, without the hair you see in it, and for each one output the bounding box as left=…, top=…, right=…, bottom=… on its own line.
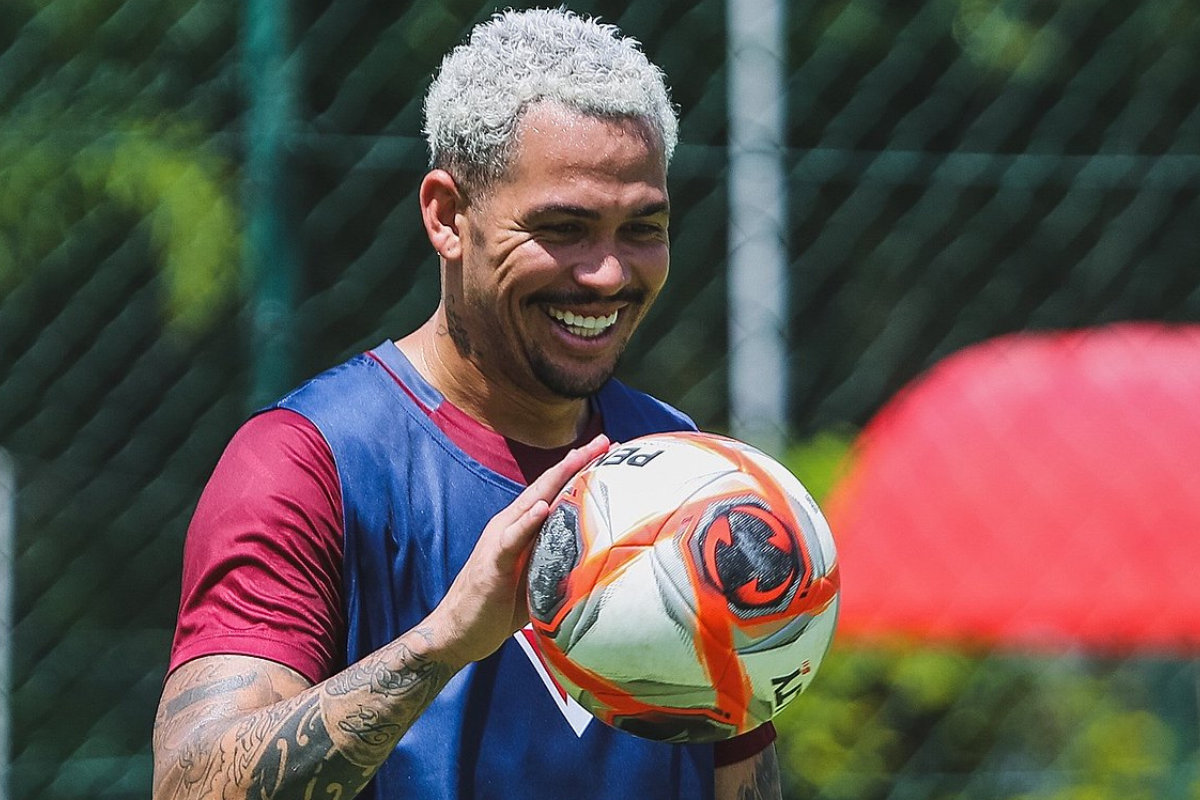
left=412, top=101, right=670, bottom=447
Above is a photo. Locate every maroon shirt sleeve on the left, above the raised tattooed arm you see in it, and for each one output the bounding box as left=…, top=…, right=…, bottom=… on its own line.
left=169, top=409, right=346, bottom=684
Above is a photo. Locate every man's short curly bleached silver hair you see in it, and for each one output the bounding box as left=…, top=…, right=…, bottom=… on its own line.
left=425, top=8, right=679, bottom=194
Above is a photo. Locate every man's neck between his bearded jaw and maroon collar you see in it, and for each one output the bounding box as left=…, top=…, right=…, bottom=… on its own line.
left=396, top=309, right=589, bottom=447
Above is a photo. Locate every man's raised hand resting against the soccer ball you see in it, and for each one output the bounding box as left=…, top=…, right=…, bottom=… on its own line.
left=426, top=434, right=610, bottom=667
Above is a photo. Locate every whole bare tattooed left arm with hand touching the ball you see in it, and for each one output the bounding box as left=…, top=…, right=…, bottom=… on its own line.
left=154, top=437, right=608, bottom=800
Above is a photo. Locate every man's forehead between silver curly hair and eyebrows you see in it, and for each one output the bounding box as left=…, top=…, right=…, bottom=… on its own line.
left=498, top=104, right=666, bottom=199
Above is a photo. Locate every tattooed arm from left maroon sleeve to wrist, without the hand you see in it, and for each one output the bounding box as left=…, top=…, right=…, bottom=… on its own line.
left=155, top=628, right=457, bottom=800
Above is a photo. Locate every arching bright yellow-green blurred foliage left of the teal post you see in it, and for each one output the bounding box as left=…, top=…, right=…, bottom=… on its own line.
left=0, top=118, right=241, bottom=333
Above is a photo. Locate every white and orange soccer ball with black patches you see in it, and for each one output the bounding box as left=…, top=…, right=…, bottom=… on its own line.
left=528, top=432, right=840, bottom=742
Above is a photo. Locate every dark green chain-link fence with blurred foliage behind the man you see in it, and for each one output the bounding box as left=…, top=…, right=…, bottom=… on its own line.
left=0, top=0, right=1200, bottom=799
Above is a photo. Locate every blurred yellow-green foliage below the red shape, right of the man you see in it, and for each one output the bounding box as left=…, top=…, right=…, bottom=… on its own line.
left=776, top=642, right=1184, bottom=800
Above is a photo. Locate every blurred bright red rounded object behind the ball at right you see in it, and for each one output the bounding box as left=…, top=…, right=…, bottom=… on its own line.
left=826, top=323, right=1200, bottom=652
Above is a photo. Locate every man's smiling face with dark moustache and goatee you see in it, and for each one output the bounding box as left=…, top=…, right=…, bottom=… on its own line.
left=445, top=107, right=670, bottom=398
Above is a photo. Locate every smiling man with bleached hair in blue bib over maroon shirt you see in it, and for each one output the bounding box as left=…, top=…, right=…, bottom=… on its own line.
left=155, top=11, right=779, bottom=800
